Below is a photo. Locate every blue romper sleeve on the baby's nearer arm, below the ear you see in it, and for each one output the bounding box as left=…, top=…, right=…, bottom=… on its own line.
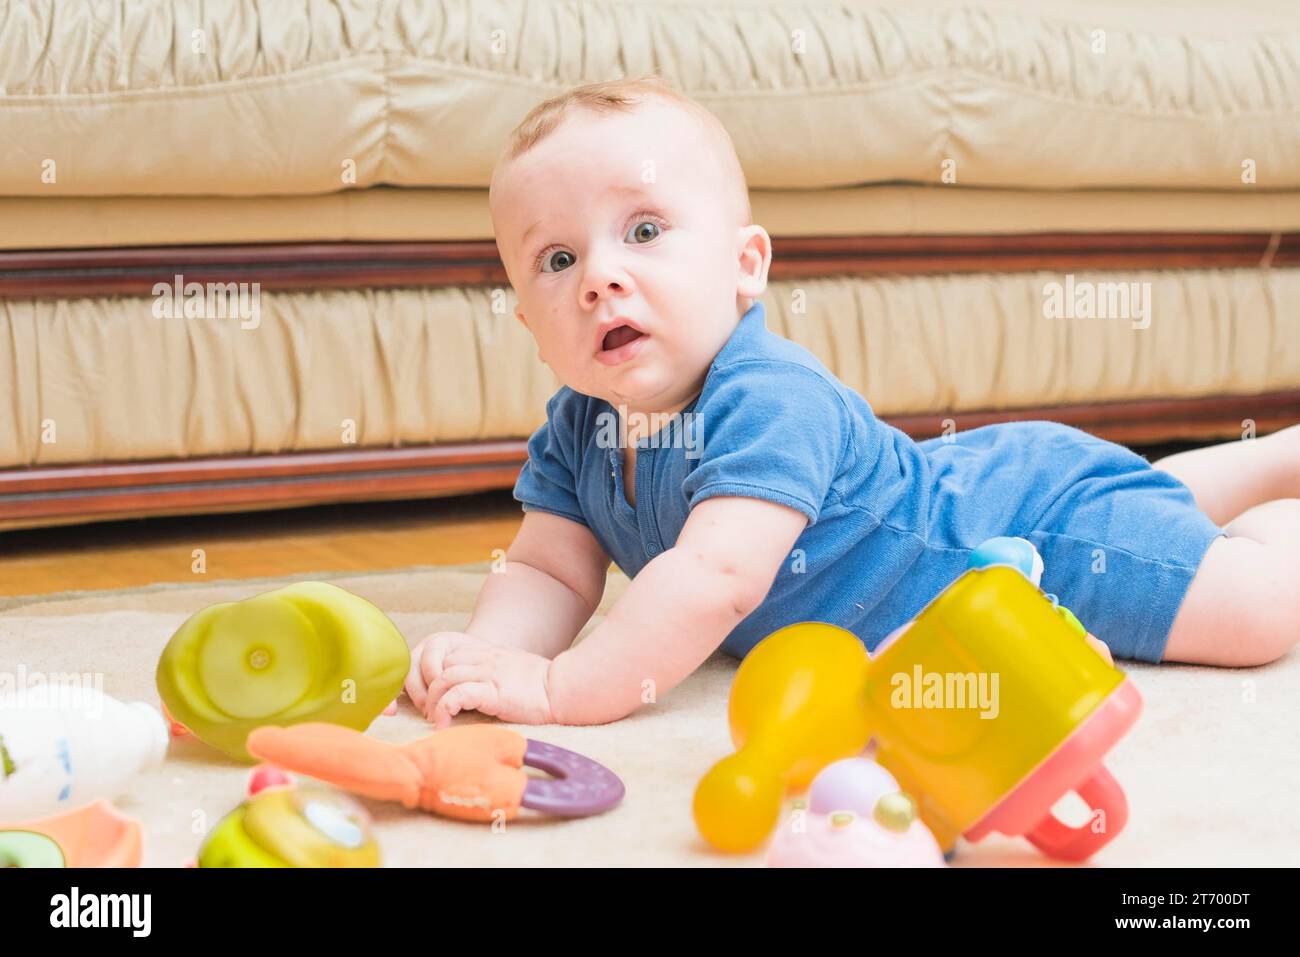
left=681, top=359, right=852, bottom=525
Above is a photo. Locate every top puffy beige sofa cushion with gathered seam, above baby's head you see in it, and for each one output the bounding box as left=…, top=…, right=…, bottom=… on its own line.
left=0, top=0, right=1300, bottom=196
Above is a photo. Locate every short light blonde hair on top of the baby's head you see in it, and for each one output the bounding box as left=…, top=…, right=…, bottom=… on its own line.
left=494, top=73, right=754, bottom=226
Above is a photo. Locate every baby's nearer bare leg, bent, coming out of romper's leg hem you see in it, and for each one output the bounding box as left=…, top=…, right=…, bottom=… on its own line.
left=1165, top=498, right=1300, bottom=667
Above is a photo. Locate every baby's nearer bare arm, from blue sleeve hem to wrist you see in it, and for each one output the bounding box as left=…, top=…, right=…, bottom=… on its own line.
left=547, top=497, right=807, bottom=724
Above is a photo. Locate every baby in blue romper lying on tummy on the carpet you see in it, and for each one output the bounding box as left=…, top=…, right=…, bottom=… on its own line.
left=406, top=78, right=1300, bottom=727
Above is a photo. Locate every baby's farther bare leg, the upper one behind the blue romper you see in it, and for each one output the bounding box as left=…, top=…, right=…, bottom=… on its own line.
left=1151, top=425, right=1300, bottom=525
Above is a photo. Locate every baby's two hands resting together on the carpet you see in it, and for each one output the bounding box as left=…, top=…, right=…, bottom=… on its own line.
left=406, top=632, right=554, bottom=728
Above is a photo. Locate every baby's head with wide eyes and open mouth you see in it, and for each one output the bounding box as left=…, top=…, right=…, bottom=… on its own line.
left=489, top=77, right=771, bottom=412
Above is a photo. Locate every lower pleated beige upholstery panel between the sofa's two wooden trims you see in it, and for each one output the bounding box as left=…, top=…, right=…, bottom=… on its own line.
left=0, top=269, right=1300, bottom=467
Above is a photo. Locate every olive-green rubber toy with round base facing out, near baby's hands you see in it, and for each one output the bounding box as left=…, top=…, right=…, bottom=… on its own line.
left=157, top=581, right=411, bottom=762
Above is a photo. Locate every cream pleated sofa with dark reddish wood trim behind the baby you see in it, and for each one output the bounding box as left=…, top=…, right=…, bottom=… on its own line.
left=0, top=0, right=1300, bottom=527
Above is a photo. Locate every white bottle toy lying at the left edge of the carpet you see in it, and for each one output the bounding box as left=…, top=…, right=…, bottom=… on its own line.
left=0, top=684, right=168, bottom=826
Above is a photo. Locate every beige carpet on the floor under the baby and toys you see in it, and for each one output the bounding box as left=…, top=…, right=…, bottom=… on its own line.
left=0, top=566, right=1300, bottom=867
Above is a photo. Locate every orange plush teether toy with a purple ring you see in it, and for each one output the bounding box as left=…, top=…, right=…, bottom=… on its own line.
left=247, top=723, right=624, bottom=820
